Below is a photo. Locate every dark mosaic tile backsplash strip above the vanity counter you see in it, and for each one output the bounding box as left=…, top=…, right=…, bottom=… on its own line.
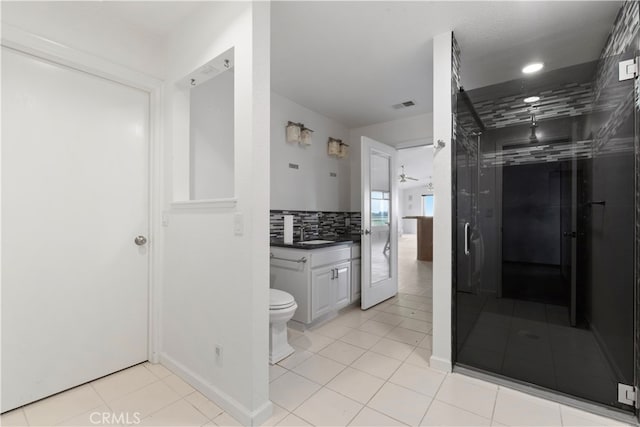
left=269, top=210, right=362, bottom=239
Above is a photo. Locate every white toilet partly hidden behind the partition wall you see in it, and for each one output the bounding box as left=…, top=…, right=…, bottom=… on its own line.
left=269, top=288, right=298, bottom=365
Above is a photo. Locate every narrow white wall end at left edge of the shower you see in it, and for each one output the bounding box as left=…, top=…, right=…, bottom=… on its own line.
left=431, top=32, right=453, bottom=371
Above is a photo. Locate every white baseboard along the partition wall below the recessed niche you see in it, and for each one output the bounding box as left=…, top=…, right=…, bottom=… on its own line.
left=160, top=353, right=273, bottom=426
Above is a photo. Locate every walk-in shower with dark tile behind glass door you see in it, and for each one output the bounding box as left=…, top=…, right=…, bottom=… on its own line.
left=453, top=2, right=640, bottom=412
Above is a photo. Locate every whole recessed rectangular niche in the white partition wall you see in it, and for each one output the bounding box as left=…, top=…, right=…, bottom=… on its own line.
left=179, top=48, right=235, bottom=201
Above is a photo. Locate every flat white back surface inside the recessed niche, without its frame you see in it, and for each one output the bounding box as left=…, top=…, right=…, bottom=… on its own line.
left=189, top=69, right=234, bottom=200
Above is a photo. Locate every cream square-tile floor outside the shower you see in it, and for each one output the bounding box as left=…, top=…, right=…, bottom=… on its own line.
left=0, top=238, right=622, bottom=426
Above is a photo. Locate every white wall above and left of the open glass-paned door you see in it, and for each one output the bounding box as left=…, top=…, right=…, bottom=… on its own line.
left=349, top=113, right=433, bottom=211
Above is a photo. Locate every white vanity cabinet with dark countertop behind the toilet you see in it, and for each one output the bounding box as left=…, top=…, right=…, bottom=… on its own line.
left=270, top=243, right=352, bottom=324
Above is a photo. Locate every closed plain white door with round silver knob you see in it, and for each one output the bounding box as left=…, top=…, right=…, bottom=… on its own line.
left=1, top=47, right=149, bottom=412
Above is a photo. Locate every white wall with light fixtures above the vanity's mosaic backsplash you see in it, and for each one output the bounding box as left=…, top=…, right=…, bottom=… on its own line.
left=271, top=93, right=350, bottom=211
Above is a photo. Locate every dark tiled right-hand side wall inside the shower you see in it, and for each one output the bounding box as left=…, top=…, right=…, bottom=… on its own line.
left=589, top=1, right=640, bottom=392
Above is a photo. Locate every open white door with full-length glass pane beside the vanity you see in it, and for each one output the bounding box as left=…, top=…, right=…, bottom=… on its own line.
left=360, top=136, right=398, bottom=309
